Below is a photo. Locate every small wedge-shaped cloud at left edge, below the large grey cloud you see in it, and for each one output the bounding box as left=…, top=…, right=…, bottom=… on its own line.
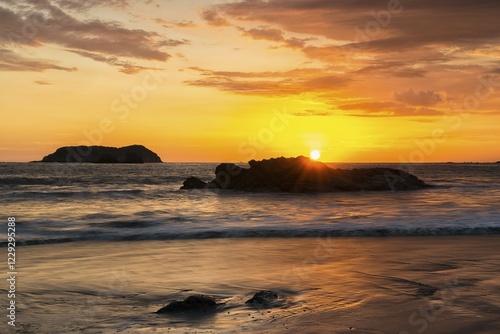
left=0, top=49, right=77, bottom=72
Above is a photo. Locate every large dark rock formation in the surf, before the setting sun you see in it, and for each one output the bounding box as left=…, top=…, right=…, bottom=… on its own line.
left=181, top=156, right=429, bottom=192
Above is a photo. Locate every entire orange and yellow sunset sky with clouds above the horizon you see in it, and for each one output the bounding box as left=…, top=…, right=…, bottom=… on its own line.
left=0, top=0, right=500, bottom=163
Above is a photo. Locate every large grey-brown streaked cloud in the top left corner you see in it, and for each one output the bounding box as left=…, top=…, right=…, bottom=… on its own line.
left=0, top=0, right=184, bottom=73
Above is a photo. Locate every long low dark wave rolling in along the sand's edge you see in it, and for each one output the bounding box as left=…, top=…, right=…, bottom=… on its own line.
left=4, top=224, right=500, bottom=247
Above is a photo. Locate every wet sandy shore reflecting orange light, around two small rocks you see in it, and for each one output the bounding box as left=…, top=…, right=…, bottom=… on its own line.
left=14, top=236, right=500, bottom=334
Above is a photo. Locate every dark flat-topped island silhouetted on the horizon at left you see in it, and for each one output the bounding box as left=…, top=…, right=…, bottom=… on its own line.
left=42, top=145, right=162, bottom=163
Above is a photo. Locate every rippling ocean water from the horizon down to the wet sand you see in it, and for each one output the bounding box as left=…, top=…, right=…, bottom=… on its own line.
left=0, top=163, right=500, bottom=244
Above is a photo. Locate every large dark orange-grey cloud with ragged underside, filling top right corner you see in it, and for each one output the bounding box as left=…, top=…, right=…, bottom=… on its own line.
left=215, top=0, right=500, bottom=78
